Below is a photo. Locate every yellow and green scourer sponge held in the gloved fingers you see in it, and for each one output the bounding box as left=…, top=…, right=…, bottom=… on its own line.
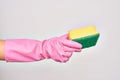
left=68, top=26, right=100, bottom=48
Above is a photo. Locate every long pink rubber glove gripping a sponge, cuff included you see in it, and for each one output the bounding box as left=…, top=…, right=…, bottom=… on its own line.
left=5, top=34, right=82, bottom=62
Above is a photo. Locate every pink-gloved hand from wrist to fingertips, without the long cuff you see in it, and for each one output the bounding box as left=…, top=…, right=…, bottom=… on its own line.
left=42, top=34, right=82, bottom=62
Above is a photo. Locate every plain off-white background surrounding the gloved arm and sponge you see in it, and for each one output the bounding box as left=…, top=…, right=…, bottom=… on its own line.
left=0, top=0, right=120, bottom=80
